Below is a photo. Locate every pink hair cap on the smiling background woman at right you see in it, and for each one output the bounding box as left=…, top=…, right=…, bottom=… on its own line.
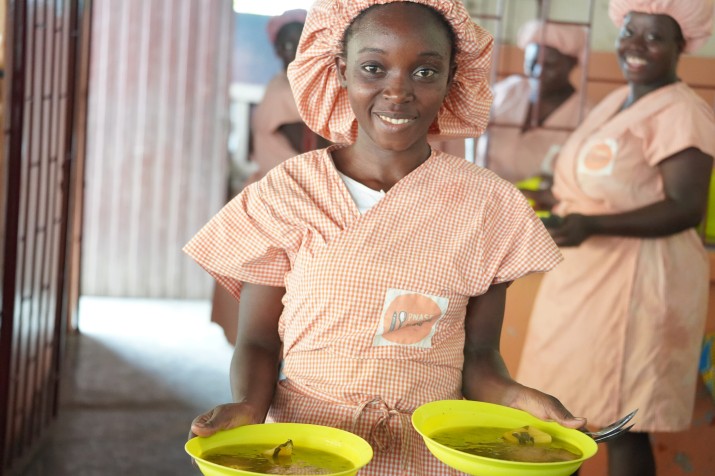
left=608, top=0, right=713, bottom=53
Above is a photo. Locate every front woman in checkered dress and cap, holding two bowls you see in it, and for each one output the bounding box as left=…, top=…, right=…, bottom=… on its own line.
left=185, top=0, right=584, bottom=476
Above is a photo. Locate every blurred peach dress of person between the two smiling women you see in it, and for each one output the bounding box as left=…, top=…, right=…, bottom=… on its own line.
left=477, top=75, right=590, bottom=183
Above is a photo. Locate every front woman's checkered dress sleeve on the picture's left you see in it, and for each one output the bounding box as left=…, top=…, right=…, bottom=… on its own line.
left=184, top=180, right=292, bottom=299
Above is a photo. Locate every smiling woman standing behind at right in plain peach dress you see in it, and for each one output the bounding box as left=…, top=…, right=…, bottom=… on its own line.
left=517, top=0, right=715, bottom=476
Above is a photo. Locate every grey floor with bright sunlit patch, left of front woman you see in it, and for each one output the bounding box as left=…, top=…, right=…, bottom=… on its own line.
left=21, top=298, right=232, bottom=476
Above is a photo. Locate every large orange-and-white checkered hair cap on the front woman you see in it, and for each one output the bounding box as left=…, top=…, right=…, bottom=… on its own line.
left=288, top=0, right=494, bottom=143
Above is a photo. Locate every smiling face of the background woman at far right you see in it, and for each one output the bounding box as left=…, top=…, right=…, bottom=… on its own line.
left=616, top=12, right=685, bottom=85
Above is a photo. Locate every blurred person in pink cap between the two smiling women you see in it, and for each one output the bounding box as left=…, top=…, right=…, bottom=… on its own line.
left=477, top=20, right=589, bottom=183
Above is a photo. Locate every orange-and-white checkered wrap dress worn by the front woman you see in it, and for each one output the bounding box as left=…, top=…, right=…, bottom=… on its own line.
left=185, top=146, right=561, bottom=476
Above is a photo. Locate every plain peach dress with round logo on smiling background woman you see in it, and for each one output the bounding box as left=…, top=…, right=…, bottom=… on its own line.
left=517, top=83, right=715, bottom=432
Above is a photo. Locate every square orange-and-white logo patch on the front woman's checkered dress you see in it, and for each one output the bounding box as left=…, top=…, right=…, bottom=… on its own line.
left=373, top=289, right=449, bottom=349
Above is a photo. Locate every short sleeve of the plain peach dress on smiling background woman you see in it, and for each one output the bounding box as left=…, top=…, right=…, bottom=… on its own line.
left=638, top=93, right=715, bottom=166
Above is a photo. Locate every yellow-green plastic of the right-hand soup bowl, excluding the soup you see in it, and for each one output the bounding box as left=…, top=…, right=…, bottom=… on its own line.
left=412, top=400, right=598, bottom=476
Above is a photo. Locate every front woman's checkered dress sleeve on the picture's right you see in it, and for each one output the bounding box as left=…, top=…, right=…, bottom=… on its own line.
left=480, top=182, right=563, bottom=284
